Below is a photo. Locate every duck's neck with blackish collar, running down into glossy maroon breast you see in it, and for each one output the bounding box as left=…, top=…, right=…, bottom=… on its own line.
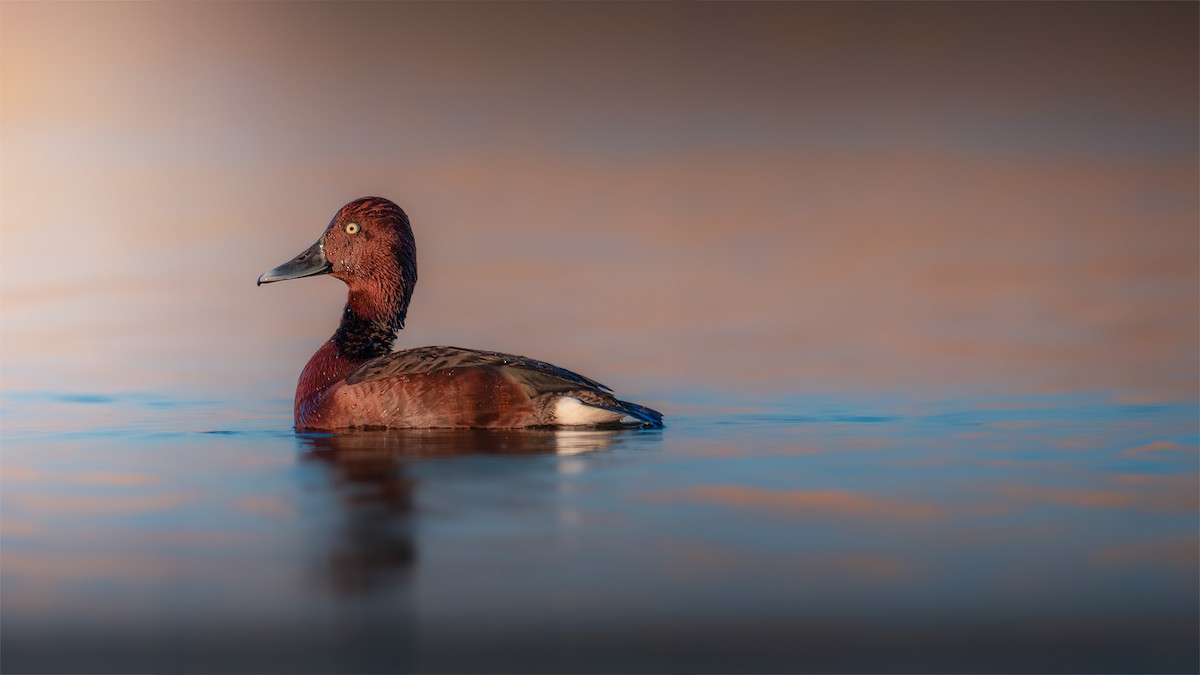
left=294, top=292, right=398, bottom=426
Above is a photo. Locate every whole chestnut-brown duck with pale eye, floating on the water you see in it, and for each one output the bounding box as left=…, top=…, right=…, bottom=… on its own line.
left=258, top=197, right=662, bottom=430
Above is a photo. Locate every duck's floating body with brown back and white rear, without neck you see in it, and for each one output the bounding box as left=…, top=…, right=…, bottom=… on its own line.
left=298, top=347, right=662, bottom=429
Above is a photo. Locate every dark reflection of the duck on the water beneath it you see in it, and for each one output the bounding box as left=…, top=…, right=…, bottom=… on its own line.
left=298, top=429, right=637, bottom=595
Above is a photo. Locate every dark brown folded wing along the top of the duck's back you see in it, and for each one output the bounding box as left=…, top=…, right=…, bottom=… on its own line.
left=346, top=347, right=612, bottom=394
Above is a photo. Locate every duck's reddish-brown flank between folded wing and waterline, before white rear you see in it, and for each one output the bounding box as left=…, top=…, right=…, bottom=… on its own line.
left=298, top=366, right=533, bottom=429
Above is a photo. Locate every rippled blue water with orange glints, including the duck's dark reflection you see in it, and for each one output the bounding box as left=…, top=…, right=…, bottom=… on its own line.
left=0, top=393, right=1200, bottom=673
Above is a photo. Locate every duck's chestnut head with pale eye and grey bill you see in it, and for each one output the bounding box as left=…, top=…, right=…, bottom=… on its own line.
left=258, top=197, right=416, bottom=328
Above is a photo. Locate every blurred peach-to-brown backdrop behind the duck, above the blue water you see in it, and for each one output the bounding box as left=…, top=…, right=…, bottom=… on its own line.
left=0, top=2, right=1200, bottom=403
